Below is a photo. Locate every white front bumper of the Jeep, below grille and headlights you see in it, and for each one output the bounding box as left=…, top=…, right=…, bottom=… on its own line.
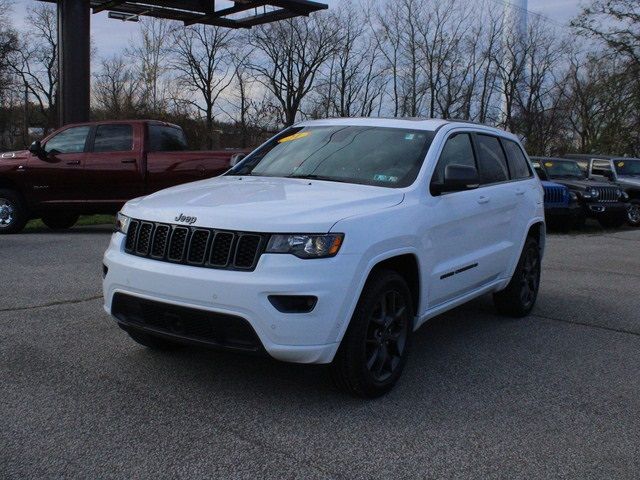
left=103, top=233, right=359, bottom=363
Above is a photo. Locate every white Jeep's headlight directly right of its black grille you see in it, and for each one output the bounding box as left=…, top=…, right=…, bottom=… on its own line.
left=266, top=233, right=344, bottom=258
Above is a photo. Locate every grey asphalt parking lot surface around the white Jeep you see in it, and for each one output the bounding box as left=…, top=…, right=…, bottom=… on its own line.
left=0, top=227, right=640, bottom=479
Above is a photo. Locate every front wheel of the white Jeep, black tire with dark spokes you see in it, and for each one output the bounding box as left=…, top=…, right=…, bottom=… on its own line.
left=330, top=270, right=414, bottom=398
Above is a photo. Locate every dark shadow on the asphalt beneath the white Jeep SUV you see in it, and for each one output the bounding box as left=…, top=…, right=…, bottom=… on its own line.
left=116, top=297, right=528, bottom=404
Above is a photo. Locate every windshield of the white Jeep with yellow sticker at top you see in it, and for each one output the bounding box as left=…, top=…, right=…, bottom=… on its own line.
left=229, top=125, right=435, bottom=188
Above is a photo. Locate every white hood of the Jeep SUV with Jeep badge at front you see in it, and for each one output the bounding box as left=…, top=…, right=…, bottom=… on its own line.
left=122, top=176, right=404, bottom=233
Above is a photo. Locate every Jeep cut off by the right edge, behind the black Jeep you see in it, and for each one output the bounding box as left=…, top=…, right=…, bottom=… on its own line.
left=565, top=154, right=640, bottom=227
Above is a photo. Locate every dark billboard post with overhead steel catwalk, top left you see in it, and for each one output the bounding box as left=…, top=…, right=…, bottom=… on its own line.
left=40, top=0, right=328, bottom=125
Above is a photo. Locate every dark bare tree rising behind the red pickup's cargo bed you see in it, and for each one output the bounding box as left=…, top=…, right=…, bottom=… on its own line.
left=171, top=25, right=234, bottom=148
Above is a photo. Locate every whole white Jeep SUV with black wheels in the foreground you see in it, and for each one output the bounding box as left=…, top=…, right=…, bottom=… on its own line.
left=104, top=119, right=545, bottom=397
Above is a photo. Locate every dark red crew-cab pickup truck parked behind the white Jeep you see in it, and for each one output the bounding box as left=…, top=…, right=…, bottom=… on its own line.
left=0, top=120, right=244, bottom=234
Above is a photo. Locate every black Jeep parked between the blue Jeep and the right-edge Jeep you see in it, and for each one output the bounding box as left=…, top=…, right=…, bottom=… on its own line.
left=531, top=157, right=629, bottom=228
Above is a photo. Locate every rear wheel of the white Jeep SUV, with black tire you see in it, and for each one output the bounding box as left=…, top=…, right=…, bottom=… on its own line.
left=493, top=237, right=540, bottom=318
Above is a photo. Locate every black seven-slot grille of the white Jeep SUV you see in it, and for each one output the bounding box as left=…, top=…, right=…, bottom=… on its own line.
left=125, top=219, right=268, bottom=271
